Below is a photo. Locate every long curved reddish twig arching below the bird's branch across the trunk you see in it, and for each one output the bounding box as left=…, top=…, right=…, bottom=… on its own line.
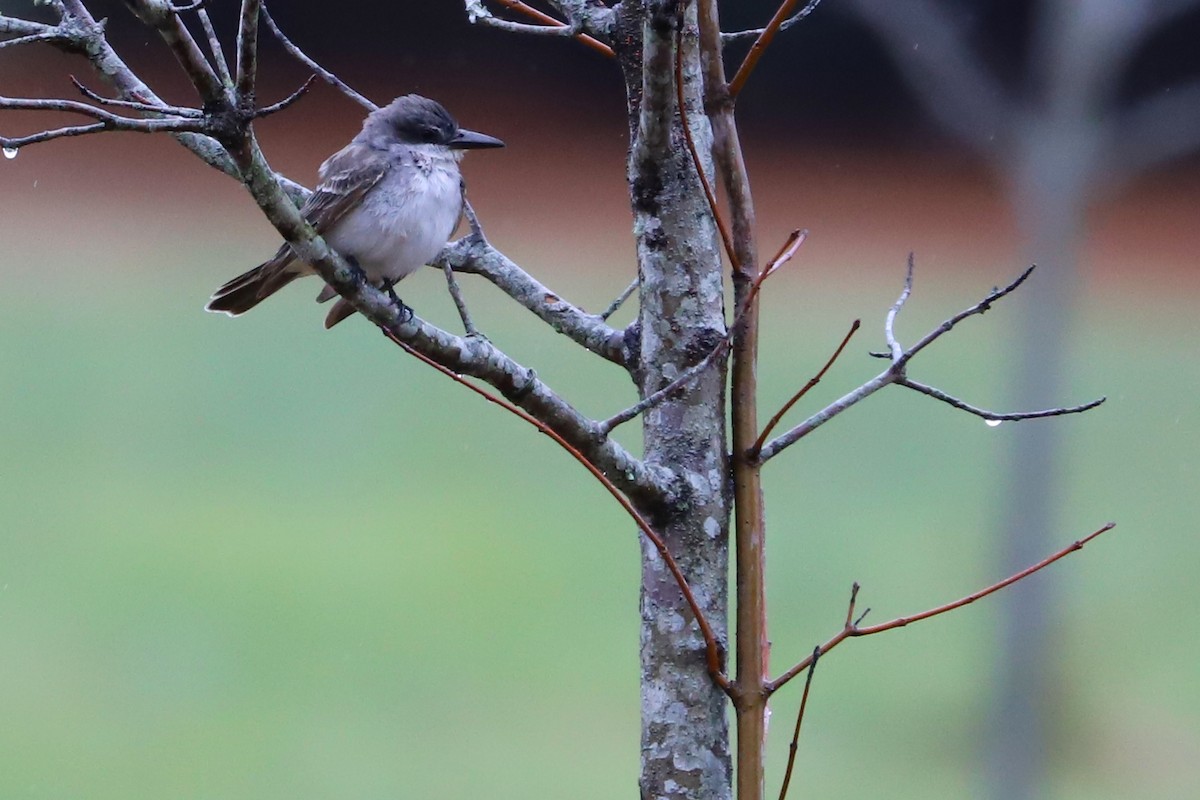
left=379, top=327, right=731, bottom=692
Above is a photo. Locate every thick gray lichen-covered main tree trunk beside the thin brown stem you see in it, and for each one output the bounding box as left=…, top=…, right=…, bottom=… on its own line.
left=614, top=0, right=732, bottom=800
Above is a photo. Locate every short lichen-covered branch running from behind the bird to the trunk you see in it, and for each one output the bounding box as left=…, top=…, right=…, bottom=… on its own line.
left=432, top=235, right=626, bottom=366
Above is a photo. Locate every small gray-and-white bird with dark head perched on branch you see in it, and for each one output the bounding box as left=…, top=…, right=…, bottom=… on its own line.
left=204, top=95, right=504, bottom=329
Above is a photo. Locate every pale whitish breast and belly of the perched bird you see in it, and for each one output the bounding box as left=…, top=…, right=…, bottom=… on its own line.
left=325, top=145, right=462, bottom=282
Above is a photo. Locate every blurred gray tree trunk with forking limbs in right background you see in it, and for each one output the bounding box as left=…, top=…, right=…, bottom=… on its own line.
left=851, top=0, right=1200, bottom=800
